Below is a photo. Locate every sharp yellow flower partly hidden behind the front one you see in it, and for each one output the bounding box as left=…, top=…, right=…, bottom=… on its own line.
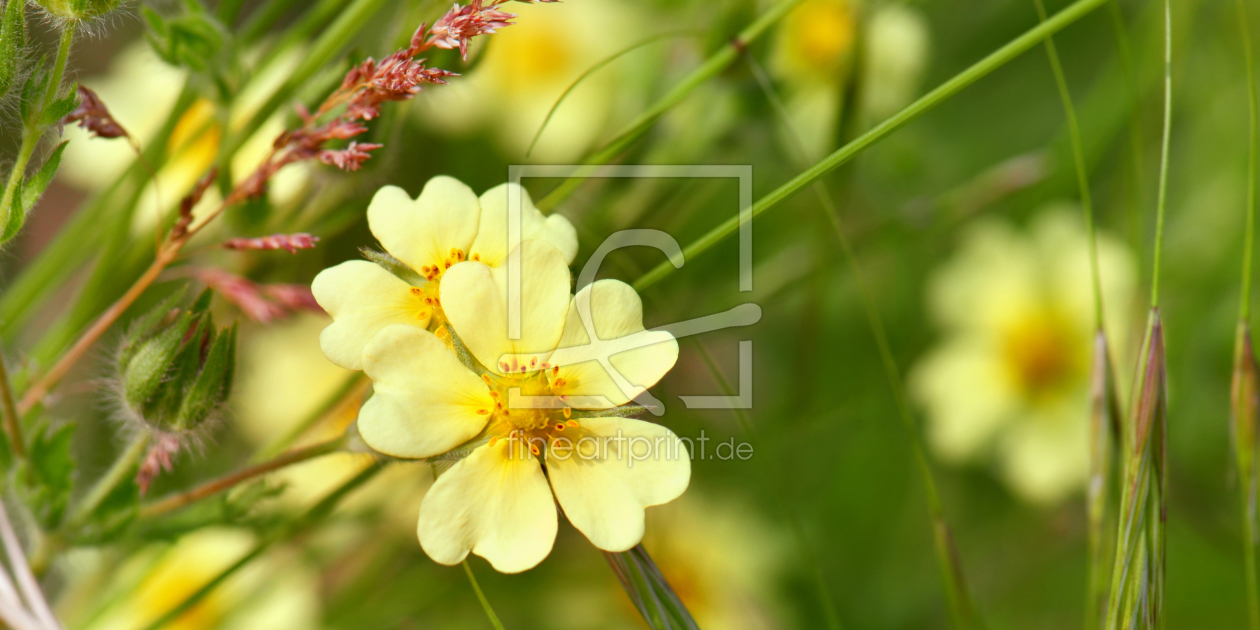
left=311, top=176, right=577, bottom=369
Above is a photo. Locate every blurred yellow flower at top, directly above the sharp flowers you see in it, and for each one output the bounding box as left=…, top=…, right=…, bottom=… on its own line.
left=412, top=0, right=650, bottom=163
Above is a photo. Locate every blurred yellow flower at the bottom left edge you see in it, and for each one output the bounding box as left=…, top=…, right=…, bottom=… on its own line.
left=68, top=528, right=320, bottom=630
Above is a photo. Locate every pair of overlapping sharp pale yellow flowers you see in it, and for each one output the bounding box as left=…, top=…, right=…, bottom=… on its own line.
left=312, top=176, right=690, bottom=572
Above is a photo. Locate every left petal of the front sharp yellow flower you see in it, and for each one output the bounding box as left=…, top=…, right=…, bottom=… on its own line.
left=359, top=325, right=494, bottom=457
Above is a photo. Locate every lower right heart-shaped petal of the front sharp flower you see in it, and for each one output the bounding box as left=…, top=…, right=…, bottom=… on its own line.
left=547, top=417, right=692, bottom=552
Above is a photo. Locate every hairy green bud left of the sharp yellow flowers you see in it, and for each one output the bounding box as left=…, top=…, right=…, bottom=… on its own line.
left=118, top=291, right=236, bottom=433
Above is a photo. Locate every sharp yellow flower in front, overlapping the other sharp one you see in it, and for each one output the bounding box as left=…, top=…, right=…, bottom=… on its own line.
left=321, top=235, right=690, bottom=573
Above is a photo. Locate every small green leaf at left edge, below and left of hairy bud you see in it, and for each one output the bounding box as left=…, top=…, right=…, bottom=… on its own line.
left=26, top=423, right=74, bottom=529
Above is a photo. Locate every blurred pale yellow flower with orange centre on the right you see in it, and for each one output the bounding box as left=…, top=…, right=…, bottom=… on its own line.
left=910, top=208, right=1135, bottom=503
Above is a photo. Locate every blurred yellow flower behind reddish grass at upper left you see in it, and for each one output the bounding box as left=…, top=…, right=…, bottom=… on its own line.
left=58, top=42, right=310, bottom=234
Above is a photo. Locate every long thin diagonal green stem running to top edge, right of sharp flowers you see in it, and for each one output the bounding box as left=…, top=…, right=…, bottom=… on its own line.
left=634, top=0, right=1108, bottom=291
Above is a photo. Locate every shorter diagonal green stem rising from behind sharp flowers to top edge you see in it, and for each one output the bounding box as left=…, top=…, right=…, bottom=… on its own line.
left=537, top=0, right=801, bottom=212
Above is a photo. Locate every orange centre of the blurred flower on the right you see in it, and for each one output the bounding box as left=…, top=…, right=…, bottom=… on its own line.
left=1002, top=309, right=1080, bottom=398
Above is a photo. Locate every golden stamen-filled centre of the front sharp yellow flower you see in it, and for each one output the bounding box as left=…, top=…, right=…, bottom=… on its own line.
left=478, top=360, right=578, bottom=456
